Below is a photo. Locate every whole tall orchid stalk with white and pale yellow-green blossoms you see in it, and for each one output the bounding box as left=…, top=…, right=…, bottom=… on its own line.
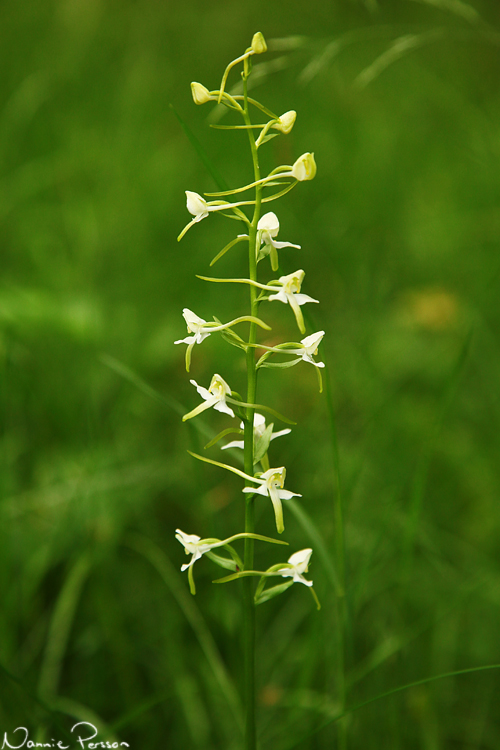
left=175, top=32, right=324, bottom=750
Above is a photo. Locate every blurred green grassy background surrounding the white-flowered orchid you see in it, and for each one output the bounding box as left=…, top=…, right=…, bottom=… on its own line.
left=0, top=0, right=500, bottom=750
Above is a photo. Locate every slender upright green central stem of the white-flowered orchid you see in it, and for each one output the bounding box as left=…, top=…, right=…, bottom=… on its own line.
left=242, top=66, right=262, bottom=750
